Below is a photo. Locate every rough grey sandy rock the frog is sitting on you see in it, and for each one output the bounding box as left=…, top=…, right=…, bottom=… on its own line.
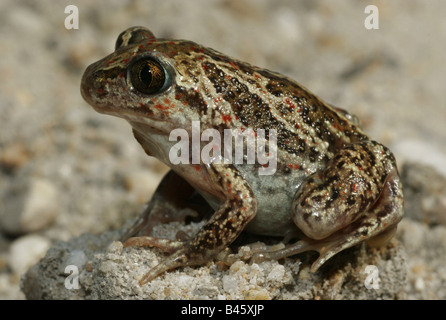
left=21, top=223, right=407, bottom=299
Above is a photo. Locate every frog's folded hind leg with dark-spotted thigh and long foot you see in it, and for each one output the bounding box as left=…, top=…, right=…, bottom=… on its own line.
left=253, top=141, right=403, bottom=271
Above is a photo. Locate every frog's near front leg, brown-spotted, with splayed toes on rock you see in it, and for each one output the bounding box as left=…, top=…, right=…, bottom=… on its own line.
left=127, top=164, right=257, bottom=285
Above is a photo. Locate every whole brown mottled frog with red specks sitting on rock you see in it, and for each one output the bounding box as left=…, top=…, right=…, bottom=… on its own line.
left=81, top=26, right=404, bottom=285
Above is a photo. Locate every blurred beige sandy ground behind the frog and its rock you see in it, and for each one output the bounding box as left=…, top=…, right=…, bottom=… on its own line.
left=0, top=0, right=446, bottom=299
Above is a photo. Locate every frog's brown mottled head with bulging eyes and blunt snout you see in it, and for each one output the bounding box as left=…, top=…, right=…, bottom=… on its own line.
left=81, top=27, right=235, bottom=133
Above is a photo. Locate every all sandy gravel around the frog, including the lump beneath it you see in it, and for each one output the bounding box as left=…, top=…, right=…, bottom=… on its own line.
left=0, top=0, right=446, bottom=299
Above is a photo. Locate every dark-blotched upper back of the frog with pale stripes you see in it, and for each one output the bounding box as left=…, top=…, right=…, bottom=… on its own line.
left=166, top=41, right=367, bottom=161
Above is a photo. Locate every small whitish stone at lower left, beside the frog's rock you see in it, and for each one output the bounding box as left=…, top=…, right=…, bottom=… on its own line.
left=8, top=235, right=51, bottom=275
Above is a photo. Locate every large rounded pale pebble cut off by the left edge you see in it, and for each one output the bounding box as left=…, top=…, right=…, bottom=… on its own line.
left=0, top=178, right=58, bottom=235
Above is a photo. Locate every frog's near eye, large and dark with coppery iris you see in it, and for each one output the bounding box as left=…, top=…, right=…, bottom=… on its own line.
left=129, top=57, right=169, bottom=94
